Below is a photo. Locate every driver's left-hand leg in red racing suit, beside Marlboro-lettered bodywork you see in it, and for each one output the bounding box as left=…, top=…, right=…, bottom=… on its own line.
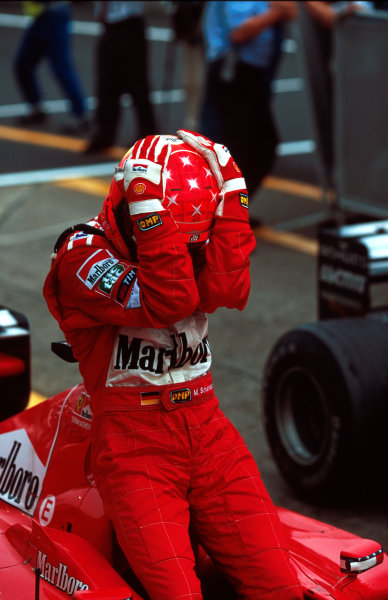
left=93, top=409, right=202, bottom=600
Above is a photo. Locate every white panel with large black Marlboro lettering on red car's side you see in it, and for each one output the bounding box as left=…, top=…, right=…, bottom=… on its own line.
left=0, top=429, right=46, bottom=515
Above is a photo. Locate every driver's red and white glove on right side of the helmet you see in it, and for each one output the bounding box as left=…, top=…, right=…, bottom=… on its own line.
left=177, top=129, right=249, bottom=223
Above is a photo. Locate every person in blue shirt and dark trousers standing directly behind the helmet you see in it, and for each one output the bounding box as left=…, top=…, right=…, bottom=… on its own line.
left=199, top=0, right=297, bottom=226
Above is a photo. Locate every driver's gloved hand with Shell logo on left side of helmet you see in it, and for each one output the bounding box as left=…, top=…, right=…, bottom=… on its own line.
left=114, top=135, right=171, bottom=214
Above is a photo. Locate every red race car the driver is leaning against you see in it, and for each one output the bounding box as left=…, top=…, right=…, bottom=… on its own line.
left=0, top=307, right=388, bottom=600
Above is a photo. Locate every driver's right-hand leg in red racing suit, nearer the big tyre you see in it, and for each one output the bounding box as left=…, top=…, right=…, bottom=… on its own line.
left=189, top=411, right=303, bottom=600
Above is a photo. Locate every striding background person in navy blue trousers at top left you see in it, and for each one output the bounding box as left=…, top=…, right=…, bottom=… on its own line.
left=14, top=2, right=88, bottom=135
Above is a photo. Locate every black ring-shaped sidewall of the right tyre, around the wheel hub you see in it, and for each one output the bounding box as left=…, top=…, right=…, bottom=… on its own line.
left=263, top=331, right=351, bottom=497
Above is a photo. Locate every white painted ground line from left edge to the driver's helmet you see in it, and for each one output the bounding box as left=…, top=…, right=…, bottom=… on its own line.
left=0, top=160, right=117, bottom=188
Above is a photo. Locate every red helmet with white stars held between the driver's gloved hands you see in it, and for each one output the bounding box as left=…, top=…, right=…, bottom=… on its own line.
left=100, top=136, right=220, bottom=254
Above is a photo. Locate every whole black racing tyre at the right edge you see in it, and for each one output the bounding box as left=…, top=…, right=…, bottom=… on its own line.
left=263, top=318, right=388, bottom=501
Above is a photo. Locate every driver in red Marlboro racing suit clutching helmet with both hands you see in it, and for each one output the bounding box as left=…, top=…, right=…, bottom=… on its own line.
left=44, top=130, right=303, bottom=600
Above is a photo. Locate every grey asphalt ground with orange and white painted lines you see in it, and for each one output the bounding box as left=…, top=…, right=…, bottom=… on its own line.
left=0, top=2, right=388, bottom=564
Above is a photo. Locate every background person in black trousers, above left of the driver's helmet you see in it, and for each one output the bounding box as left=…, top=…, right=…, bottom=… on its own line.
left=84, top=1, right=156, bottom=154
